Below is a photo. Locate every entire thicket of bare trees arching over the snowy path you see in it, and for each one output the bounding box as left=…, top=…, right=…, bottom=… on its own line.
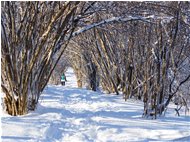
left=1, top=1, right=190, bottom=119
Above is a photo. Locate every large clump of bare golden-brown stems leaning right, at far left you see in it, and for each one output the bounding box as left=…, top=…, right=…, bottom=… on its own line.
left=1, top=2, right=92, bottom=115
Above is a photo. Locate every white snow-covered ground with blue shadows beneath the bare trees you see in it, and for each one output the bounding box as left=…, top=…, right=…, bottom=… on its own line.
left=1, top=69, right=190, bottom=142
